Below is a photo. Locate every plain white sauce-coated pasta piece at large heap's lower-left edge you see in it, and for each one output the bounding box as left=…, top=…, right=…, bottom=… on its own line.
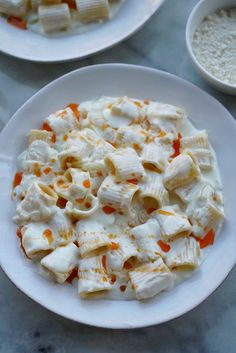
left=40, top=243, right=78, bottom=283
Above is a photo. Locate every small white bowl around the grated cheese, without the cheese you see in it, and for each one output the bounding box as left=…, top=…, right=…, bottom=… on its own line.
left=186, top=0, right=236, bottom=95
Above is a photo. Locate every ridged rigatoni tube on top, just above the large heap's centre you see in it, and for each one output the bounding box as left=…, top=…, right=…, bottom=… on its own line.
left=104, top=148, right=146, bottom=182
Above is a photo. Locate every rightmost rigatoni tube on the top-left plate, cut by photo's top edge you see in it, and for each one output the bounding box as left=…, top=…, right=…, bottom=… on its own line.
left=76, top=0, right=110, bottom=23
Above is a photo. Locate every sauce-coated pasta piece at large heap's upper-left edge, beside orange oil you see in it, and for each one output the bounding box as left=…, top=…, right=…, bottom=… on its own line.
left=45, top=108, right=79, bottom=136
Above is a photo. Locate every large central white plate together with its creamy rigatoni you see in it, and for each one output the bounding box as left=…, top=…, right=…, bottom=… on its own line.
left=0, top=64, right=236, bottom=328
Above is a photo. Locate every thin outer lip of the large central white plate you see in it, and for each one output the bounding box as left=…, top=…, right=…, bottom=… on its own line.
left=0, top=63, right=236, bottom=329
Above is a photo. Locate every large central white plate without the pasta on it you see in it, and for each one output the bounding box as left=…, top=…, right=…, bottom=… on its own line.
left=0, top=64, right=236, bottom=328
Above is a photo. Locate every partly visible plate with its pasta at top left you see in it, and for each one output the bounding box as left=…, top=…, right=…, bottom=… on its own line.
left=0, top=0, right=164, bottom=62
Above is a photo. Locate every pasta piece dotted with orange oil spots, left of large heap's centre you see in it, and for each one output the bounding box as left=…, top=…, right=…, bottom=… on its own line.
left=54, top=168, right=91, bottom=203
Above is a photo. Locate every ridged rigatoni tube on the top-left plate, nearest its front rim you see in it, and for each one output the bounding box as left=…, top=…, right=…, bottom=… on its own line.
left=38, top=3, right=71, bottom=33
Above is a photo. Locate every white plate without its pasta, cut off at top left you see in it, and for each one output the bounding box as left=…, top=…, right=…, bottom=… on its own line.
left=0, top=0, right=164, bottom=62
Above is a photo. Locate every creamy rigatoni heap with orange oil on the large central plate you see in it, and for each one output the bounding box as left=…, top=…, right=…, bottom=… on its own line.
left=12, top=95, right=224, bottom=300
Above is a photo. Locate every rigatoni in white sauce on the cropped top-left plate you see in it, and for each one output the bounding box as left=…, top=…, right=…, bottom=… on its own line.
left=0, top=0, right=124, bottom=35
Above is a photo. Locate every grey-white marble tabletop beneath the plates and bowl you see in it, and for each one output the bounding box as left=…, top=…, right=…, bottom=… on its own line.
left=0, top=0, right=236, bottom=353
